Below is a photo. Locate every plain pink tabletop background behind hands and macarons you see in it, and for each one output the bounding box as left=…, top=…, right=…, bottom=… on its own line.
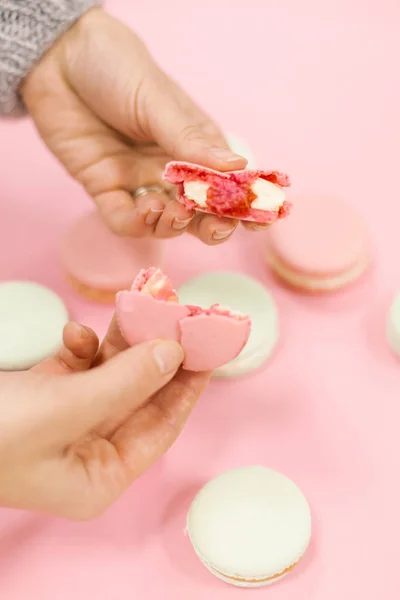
left=0, top=0, right=400, bottom=600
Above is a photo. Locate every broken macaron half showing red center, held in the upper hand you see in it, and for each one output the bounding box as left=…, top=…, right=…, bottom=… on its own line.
left=163, top=161, right=291, bottom=225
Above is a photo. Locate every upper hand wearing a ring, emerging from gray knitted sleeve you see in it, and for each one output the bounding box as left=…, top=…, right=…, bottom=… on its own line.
left=21, top=9, right=260, bottom=244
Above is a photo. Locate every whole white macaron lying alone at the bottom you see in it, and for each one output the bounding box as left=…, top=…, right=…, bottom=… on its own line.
left=186, top=466, right=311, bottom=587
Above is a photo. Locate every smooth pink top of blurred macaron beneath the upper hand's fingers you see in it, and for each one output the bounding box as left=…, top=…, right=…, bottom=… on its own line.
left=61, top=212, right=162, bottom=290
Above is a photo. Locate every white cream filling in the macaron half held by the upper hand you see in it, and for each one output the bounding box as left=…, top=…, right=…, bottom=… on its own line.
left=183, top=178, right=285, bottom=211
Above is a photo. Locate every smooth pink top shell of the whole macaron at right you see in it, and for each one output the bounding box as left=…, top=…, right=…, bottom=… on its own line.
left=266, top=196, right=370, bottom=276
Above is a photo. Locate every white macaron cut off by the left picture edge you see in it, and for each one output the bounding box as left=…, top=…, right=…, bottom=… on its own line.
left=0, top=281, right=68, bottom=371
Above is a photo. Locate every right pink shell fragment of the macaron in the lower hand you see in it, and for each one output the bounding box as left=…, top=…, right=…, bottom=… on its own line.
left=180, top=314, right=251, bottom=371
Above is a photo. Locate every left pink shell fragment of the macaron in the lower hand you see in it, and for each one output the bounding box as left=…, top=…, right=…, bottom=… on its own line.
left=116, top=291, right=189, bottom=346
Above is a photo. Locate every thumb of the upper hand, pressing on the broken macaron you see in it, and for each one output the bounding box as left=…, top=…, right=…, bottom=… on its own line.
left=145, top=72, right=247, bottom=171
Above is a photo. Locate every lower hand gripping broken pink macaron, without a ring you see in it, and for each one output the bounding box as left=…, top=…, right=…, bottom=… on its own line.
left=0, top=320, right=210, bottom=520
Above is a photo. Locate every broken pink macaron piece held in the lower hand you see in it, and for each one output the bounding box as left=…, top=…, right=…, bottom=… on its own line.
left=116, top=267, right=251, bottom=371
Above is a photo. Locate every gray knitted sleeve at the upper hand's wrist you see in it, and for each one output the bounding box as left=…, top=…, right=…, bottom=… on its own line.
left=0, top=0, right=102, bottom=116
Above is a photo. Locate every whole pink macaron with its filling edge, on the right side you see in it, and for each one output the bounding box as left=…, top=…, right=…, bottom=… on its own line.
left=264, top=197, right=371, bottom=292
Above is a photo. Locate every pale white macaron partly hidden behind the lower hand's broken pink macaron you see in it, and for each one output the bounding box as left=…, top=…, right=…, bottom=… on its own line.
left=178, top=271, right=279, bottom=378
